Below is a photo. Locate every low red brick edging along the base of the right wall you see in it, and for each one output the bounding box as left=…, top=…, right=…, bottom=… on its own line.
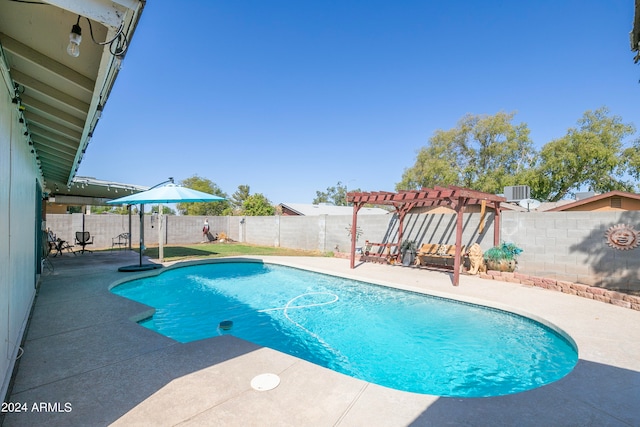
left=479, top=270, right=640, bottom=311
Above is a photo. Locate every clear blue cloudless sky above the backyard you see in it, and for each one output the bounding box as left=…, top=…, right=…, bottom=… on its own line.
left=78, top=0, right=640, bottom=204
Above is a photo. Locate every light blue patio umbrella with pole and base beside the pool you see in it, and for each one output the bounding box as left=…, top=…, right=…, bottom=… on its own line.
left=107, top=183, right=225, bottom=271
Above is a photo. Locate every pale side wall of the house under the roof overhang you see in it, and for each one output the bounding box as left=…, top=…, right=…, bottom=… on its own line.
left=0, top=76, right=40, bottom=397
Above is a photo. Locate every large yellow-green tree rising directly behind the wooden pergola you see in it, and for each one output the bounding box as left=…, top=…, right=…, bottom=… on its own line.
left=396, top=112, right=535, bottom=193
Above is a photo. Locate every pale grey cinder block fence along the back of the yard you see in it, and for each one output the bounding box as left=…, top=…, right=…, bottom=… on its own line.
left=47, top=211, right=640, bottom=294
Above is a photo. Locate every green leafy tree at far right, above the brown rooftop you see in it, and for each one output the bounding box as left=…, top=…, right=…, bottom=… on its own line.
left=527, top=107, right=640, bottom=201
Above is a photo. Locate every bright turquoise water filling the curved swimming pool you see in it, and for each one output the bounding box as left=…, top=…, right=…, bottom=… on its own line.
left=112, top=262, right=578, bottom=397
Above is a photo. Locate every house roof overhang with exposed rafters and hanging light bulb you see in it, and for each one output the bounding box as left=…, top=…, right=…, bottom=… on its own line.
left=0, top=0, right=145, bottom=197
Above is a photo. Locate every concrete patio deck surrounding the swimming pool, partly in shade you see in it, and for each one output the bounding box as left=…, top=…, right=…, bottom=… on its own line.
left=3, top=251, right=640, bottom=427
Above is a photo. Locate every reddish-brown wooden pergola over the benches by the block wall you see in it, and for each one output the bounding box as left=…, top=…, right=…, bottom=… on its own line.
left=347, top=186, right=507, bottom=286
